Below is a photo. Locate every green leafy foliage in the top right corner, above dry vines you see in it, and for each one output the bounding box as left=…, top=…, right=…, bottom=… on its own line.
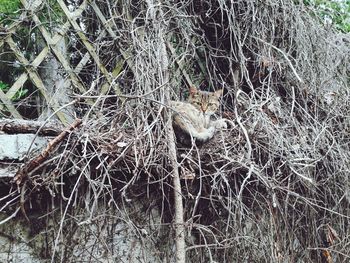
left=304, top=0, right=350, bottom=33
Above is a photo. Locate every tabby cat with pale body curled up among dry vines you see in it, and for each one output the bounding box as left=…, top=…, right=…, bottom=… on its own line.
left=170, top=87, right=227, bottom=143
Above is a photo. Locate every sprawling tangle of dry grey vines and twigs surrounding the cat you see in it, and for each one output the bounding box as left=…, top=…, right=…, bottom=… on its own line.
left=1, top=0, right=350, bottom=262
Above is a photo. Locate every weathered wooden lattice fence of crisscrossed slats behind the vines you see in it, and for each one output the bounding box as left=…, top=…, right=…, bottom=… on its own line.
left=0, top=0, right=206, bottom=124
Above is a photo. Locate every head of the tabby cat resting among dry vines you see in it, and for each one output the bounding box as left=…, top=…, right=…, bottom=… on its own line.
left=188, top=87, right=223, bottom=115
